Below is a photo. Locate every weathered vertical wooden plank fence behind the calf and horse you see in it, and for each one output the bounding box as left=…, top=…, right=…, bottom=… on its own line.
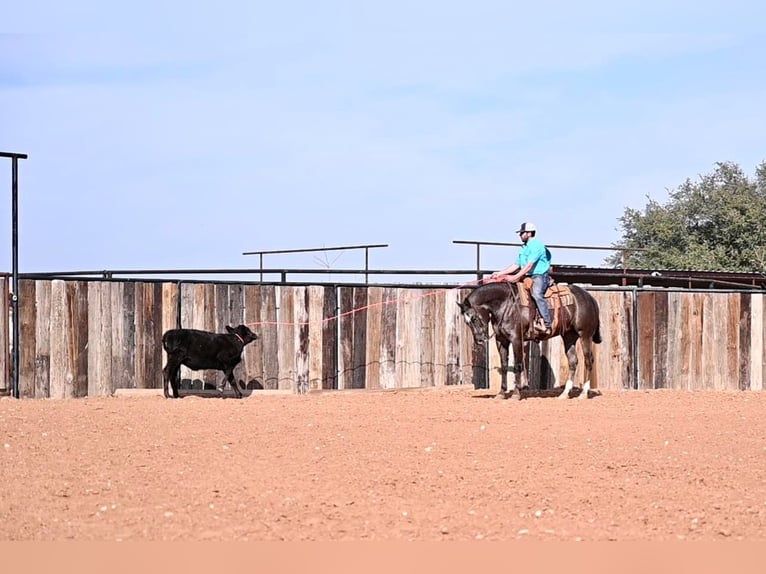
left=0, top=279, right=766, bottom=398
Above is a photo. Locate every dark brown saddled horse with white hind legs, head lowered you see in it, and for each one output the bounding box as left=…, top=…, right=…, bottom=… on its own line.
left=457, top=281, right=601, bottom=399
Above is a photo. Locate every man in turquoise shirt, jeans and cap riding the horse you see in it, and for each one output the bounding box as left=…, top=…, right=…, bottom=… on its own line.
left=489, top=222, right=551, bottom=339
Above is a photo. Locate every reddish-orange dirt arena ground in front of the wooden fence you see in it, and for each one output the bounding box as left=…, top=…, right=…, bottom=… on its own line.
left=0, top=387, right=766, bottom=541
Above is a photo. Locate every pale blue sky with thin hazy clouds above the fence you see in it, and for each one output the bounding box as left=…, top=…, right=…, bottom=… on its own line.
left=0, top=0, right=766, bottom=284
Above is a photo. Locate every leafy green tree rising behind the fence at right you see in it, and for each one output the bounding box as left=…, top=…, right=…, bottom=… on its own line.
left=606, top=162, right=766, bottom=272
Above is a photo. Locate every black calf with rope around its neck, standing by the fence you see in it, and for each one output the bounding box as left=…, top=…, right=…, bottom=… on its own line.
left=162, top=325, right=258, bottom=399
